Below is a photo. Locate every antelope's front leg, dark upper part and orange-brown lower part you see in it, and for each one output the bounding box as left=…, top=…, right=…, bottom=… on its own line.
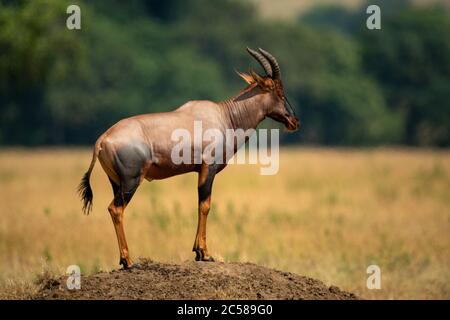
left=192, top=164, right=216, bottom=261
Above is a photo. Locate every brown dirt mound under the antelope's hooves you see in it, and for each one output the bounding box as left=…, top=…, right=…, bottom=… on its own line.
left=34, top=259, right=357, bottom=300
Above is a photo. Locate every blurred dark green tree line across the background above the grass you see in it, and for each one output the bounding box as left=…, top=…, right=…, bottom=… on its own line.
left=0, top=0, right=450, bottom=146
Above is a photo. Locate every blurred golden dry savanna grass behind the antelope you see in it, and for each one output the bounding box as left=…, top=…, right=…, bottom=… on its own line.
left=0, top=148, right=450, bottom=299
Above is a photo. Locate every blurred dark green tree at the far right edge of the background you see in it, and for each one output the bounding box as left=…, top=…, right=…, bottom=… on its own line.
left=361, top=7, right=450, bottom=146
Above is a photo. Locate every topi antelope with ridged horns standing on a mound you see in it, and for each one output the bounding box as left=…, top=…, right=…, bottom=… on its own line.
left=79, top=48, right=299, bottom=269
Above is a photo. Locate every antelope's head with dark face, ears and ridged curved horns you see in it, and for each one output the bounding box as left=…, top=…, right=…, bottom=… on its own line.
left=238, top=48, right=300, bottom=131
